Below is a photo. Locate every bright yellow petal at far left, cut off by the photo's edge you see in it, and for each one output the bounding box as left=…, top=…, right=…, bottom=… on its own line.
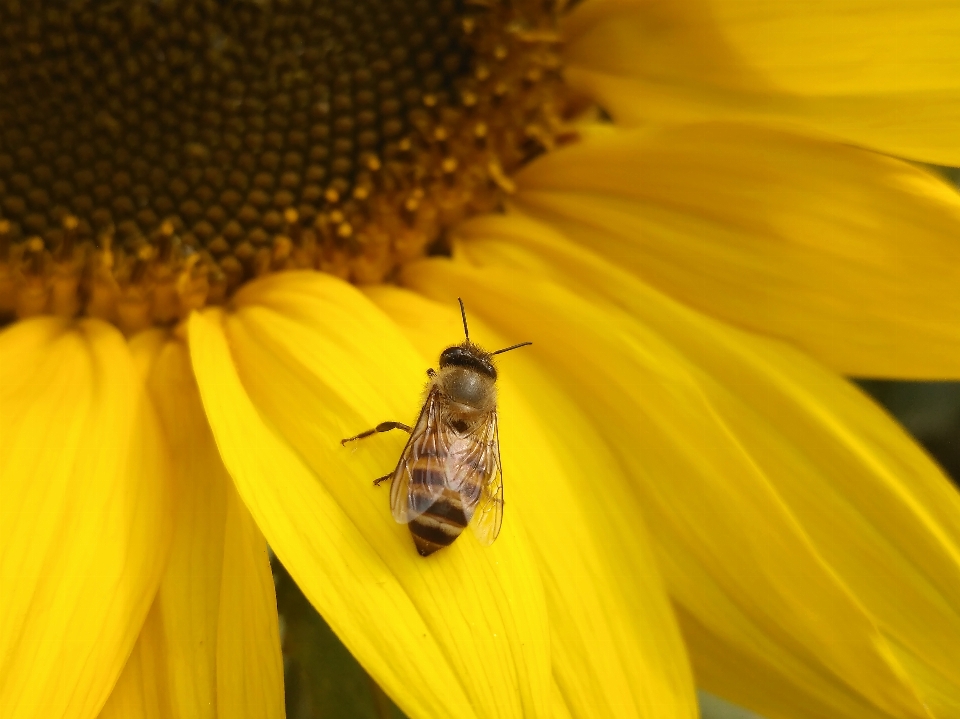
left=0, top=318, right=171, bottom=717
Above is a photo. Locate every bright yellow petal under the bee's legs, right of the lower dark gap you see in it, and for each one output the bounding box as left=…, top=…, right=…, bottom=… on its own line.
left=189, top=273, right=550, bottom=717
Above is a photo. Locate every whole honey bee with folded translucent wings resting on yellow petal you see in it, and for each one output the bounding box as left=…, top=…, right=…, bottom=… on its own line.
left=340, top=299, right=533, bottom=557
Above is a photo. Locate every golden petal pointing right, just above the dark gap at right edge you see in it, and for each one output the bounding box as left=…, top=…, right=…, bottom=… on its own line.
left=516, top=125, right=960, bottom=378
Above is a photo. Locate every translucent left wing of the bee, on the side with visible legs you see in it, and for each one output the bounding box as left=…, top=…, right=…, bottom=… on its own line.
left=390, top=389, right=446, bottom=524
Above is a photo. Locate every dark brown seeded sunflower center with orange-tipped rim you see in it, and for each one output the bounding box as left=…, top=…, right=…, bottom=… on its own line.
left=0, top=0, right=567, bottom=332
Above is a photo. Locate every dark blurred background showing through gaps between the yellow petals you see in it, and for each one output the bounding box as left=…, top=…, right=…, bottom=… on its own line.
left=274, top=380, right=960, bottom=719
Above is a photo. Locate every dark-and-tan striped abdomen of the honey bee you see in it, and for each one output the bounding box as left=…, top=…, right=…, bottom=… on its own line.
left=408, top=457, right=480, bottom=557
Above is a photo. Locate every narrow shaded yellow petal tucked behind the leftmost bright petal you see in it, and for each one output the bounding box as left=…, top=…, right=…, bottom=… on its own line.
left=104, top=331, right=283, bottom=718
